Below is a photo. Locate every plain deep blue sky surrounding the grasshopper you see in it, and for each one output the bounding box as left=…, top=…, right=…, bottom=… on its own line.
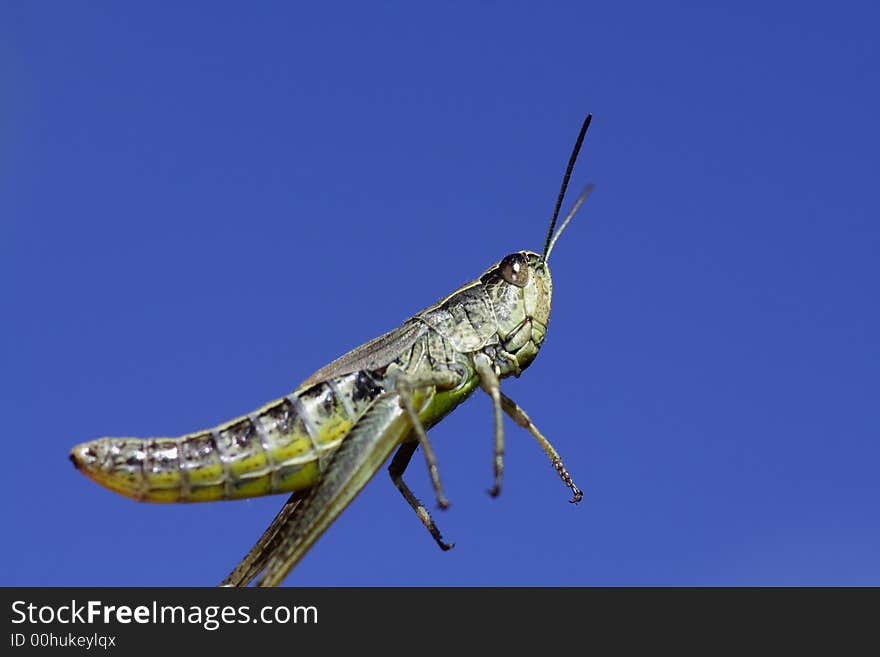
left=0, top=2, right=880, bottom=586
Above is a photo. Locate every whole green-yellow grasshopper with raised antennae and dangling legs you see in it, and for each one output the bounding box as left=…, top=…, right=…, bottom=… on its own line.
left=71, top=115, right=592, bottom=586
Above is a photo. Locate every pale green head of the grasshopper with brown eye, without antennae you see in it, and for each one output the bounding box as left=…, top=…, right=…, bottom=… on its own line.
left=480, top=251, right=553, bottom=370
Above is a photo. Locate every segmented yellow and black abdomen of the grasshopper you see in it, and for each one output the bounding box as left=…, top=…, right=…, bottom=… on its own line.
left=71, top=372, right=382, bottom=502
